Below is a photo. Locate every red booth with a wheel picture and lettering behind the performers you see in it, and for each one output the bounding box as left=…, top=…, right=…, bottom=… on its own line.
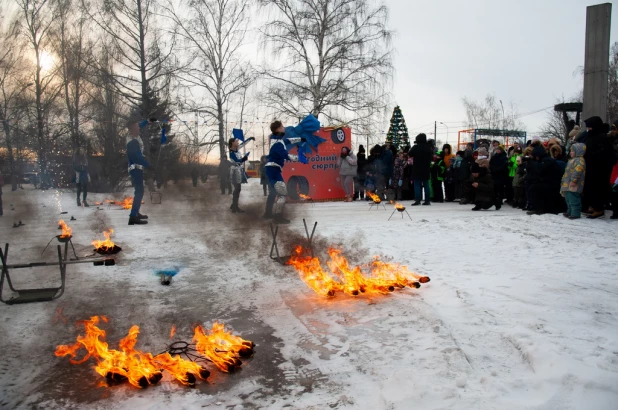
left=283, top=128, right=352, bottom=201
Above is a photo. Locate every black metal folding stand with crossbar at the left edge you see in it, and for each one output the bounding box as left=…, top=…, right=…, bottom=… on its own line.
left=0, top=243, right=116, bottom=305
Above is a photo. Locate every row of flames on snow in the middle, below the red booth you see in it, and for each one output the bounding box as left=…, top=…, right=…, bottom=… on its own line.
left=288, top=246, right=430, bottom=296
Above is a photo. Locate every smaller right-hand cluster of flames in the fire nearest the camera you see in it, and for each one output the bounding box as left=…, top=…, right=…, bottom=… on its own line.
left=193, top=322, right=253, bottom=372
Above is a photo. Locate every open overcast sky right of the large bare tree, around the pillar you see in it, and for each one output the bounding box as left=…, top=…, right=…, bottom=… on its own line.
left=386, top=0, right=618, bottom=141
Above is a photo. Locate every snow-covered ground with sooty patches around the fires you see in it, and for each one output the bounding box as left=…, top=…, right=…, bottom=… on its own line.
left=0, top=180, right=618, bottom=409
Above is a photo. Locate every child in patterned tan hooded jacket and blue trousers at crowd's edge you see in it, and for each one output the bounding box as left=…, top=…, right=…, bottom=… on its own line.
left=560, top=143, right=586, bottom=219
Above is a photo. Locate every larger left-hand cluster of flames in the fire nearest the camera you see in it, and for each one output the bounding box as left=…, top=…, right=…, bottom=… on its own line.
left=54, top=316, right=210, bottom=388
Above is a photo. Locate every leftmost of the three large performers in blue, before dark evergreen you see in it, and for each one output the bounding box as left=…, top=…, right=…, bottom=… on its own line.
left=127, top=121, right=150, bottom=225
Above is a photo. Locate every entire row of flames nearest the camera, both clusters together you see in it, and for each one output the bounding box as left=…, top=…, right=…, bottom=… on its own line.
left=54, top=316, right=254, bottom=388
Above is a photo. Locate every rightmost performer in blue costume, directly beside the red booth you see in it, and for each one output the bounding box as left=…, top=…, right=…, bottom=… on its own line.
left=264, top=121, right=306, bottom=224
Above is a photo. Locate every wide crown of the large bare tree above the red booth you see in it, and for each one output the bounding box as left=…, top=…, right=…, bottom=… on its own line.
left=259, top=0, right=392, bottom=125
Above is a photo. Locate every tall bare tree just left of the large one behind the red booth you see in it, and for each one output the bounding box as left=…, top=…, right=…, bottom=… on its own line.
left=167, top=0, right=254, bottom=160
